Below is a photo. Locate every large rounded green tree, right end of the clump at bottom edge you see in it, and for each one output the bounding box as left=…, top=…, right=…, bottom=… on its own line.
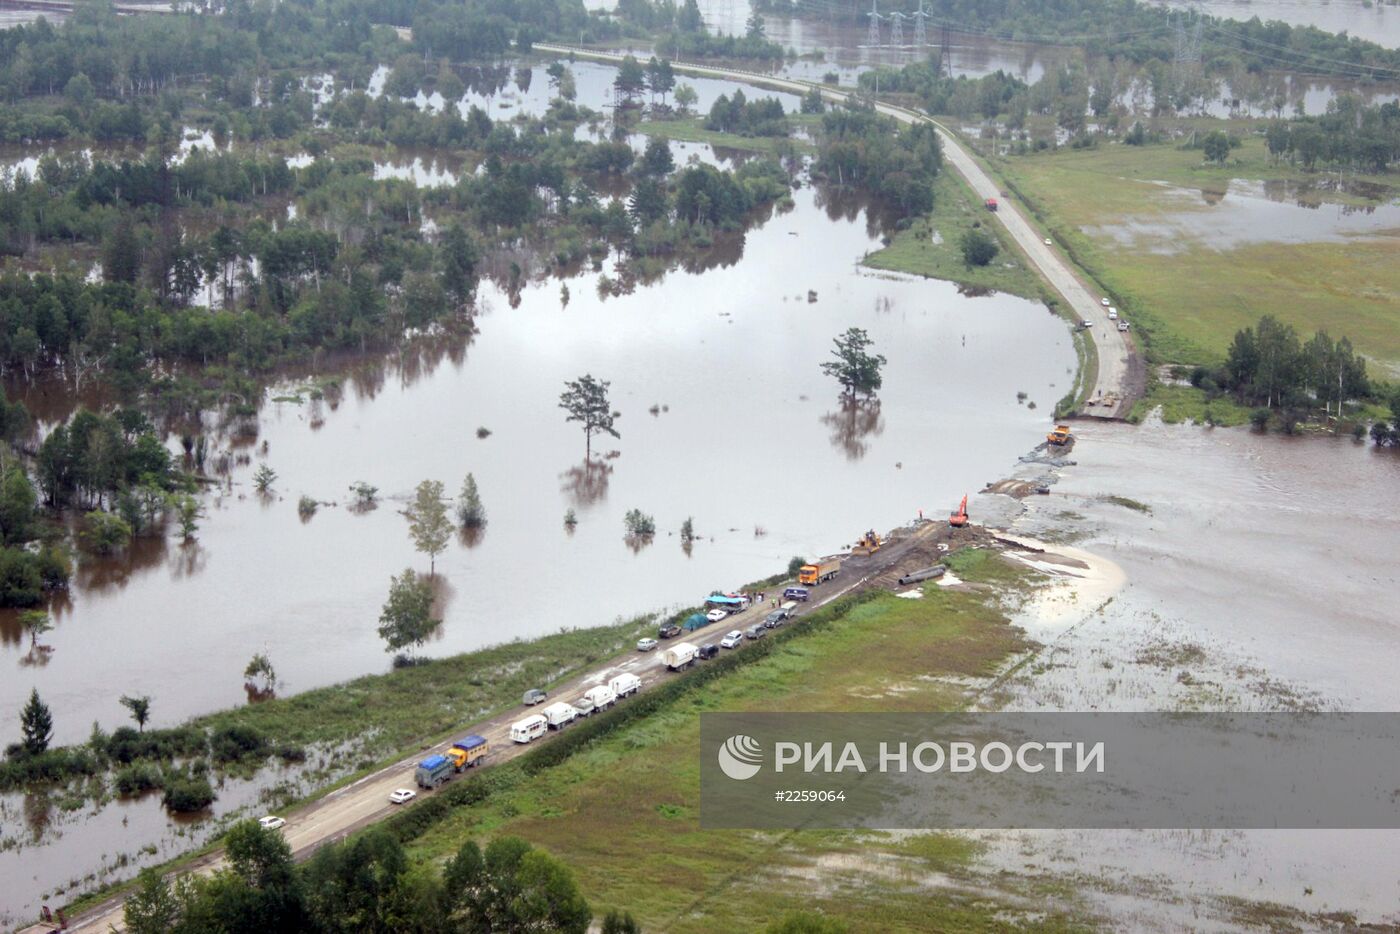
left=442, top=836, right=592, bottom=934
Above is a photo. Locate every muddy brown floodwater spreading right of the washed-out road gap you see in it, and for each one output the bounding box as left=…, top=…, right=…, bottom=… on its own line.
left=979, top=420, right=1400, bottom=930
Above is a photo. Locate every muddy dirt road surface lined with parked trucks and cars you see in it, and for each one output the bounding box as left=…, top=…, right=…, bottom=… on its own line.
left=43, top=521, right=991, bottom=934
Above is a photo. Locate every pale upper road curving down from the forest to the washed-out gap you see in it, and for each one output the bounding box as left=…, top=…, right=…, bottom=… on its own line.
left=535, top=42, right=1142, bottom=419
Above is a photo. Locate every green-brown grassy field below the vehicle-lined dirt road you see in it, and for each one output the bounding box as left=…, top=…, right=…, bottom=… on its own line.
left=412, top=574, right=1092, bottom=931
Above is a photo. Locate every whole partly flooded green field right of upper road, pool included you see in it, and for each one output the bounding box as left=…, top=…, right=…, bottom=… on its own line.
left=997, top=137, right=1400, bottom=375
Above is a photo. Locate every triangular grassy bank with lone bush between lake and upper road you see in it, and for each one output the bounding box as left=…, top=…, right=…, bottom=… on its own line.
left=864, top=168, right=1044, bottom=300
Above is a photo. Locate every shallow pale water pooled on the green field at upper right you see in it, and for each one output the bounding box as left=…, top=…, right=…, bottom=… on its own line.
left=1085, top=179, right=1400, bottom=253
